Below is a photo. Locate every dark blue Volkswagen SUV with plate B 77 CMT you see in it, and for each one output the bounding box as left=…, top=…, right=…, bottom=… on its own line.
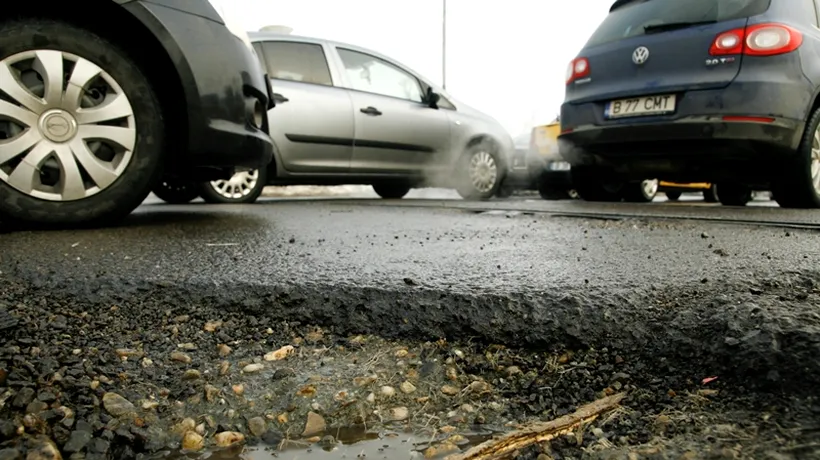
left=559, top=0, right=820, bottom=208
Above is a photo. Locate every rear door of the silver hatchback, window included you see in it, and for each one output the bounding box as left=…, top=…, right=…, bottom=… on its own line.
left=259, top=40, right=354, bottom=174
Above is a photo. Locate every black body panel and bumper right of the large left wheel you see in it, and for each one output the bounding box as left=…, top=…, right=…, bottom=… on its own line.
left=124, top=2, right=273, bottom=170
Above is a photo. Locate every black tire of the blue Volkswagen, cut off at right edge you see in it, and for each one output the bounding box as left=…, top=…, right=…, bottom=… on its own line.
left=772, top=109, right=820, bottom=209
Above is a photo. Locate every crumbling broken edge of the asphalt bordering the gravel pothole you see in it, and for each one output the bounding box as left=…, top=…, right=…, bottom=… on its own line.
left=0, top=270, right=820, bottom=394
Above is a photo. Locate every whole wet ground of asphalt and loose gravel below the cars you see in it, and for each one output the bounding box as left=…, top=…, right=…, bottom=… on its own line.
left=0, top=188, right=820, bottom=460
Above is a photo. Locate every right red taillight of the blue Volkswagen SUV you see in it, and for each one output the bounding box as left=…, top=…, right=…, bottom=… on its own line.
left=709, top=23, right=803, bottom=56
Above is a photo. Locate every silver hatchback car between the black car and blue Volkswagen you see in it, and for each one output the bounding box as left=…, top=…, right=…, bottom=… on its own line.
left=167, top=32, right=526, bottom=203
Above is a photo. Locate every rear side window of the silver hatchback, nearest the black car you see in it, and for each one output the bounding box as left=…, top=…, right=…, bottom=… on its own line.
left=262, top=41, right=333, bottom=86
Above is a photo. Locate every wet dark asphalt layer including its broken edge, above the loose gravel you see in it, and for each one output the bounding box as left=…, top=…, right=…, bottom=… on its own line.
left=0, top=192, right=820, bottom=390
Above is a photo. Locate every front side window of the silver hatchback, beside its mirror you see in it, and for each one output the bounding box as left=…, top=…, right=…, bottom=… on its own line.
left=337, top=48, right=424, bottom=103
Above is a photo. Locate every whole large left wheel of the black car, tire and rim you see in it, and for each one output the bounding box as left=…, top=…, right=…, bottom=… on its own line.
left=0, top=19, right=165, bottom=227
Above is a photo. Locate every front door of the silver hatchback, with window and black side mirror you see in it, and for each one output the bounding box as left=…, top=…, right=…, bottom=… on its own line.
left=335, top=46, right=450, bottom=174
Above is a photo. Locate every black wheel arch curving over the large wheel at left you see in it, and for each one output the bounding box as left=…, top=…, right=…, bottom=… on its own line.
left=0, top=0, right=193, bottom=166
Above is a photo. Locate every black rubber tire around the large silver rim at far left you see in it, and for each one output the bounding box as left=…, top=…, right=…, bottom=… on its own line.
left=0, top=19, right=165, bottom=228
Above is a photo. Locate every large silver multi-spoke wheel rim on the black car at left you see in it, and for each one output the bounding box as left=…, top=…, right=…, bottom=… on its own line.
left=0, top=50, right=137, bottom=201
